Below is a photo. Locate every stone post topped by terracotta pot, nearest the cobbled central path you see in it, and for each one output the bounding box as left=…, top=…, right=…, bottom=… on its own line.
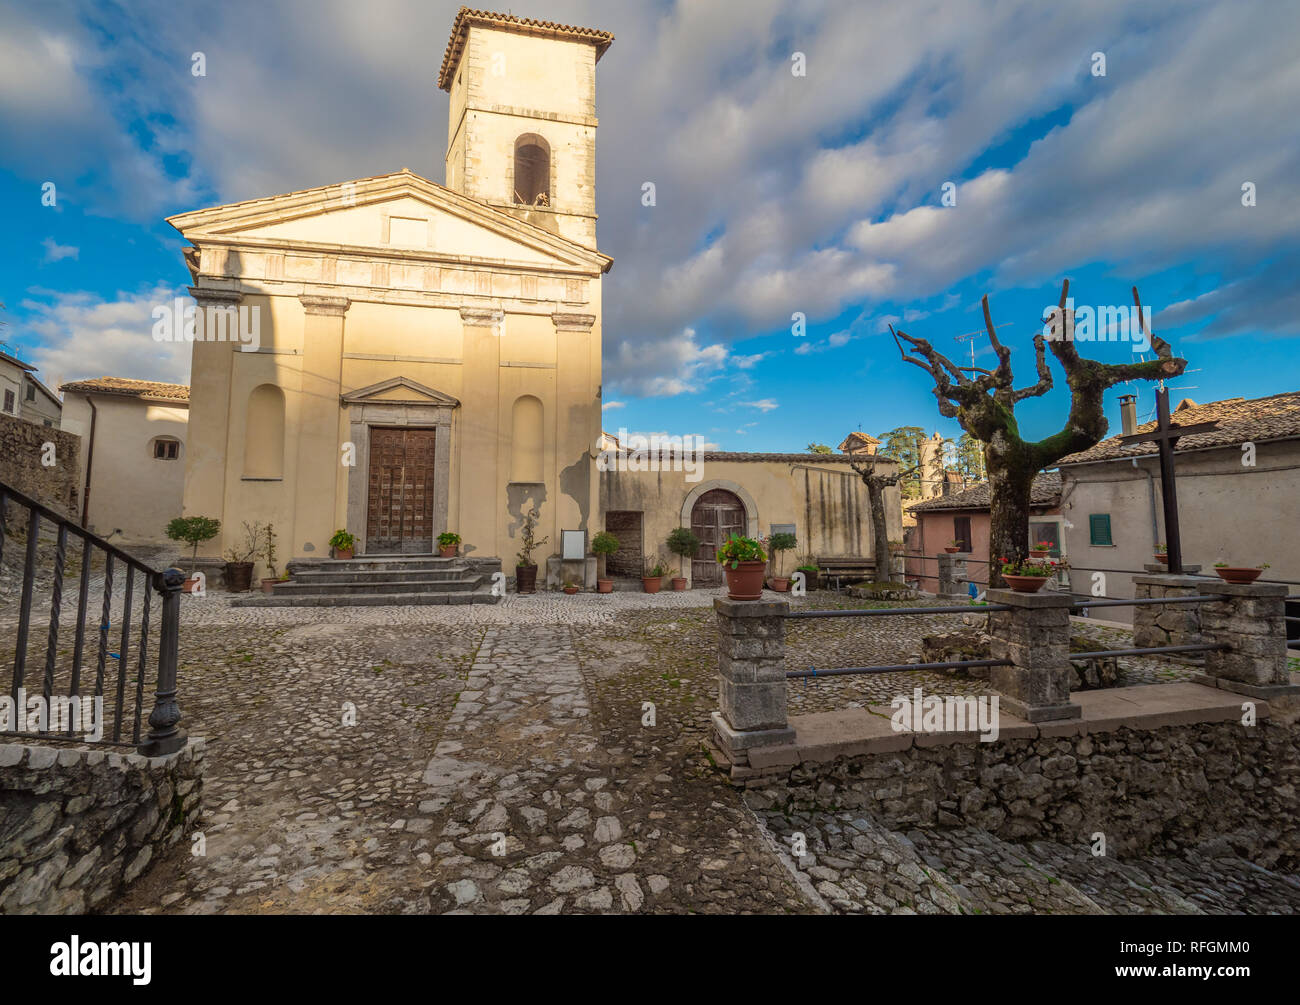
left=712, top=597, right=794, bottom=764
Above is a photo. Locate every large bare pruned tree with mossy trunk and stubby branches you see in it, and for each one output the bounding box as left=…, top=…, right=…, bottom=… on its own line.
left=889, top=280, right=1187, bottom=586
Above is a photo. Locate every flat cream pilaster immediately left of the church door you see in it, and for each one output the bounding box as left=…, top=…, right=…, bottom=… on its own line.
left=295, top=294, right=351, bottom=558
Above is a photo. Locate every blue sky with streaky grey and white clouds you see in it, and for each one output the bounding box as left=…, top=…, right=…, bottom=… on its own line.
left=0, top=0, right=1300, bottom=451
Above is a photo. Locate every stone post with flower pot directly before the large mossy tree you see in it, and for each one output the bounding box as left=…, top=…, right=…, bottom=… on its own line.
left=988, top=590, right=1083, bottom=723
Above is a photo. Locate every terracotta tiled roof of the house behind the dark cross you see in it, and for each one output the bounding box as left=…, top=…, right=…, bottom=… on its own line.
left=1058, top=391, right=1300, bottom=464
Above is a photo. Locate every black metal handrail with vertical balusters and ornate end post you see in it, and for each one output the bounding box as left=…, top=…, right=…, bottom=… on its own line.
left=0, top=482, right=186, bottom=757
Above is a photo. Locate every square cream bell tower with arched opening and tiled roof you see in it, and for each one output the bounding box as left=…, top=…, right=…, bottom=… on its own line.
left=438, top=7, right=614, bottom=248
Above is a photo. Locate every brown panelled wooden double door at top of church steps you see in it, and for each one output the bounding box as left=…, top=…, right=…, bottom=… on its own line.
left=365, top=426, right=439, bottom=555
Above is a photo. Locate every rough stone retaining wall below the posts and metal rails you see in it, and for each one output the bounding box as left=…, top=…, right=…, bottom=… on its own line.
left=746, top=699, right=1300, bottom=871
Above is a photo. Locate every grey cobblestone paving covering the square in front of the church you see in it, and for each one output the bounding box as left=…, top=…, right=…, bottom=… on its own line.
left=0, top=553, right=1300, bottom=914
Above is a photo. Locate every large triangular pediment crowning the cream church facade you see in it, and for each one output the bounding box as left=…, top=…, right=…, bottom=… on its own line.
left=168, top=170, right=612, bottom=272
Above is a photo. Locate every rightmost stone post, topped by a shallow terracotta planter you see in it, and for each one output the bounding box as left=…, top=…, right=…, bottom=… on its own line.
left=1195, top=582, right=1300, bottom=698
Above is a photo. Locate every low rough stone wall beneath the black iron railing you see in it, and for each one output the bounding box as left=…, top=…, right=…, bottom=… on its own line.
left=0, top=740, right=203, bottom=914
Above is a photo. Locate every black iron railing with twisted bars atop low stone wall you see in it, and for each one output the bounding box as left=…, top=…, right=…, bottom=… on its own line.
left=0, top=482, right=186, bottom=757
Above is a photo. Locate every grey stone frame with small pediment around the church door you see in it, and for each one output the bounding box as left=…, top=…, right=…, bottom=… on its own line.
left=342, top=377, right=460, bottom=555
